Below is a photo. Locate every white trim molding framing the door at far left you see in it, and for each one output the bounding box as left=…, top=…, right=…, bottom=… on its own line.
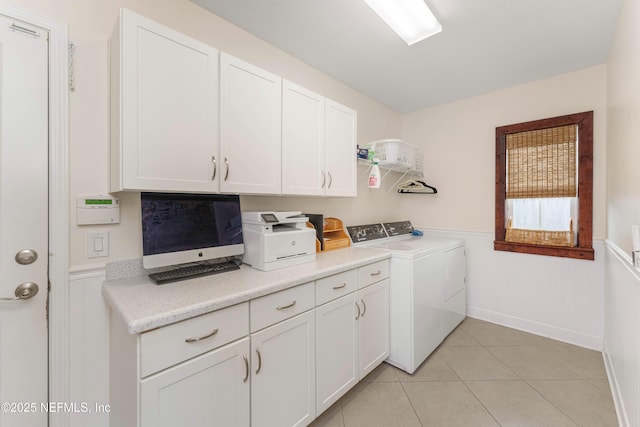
left=0, top=3, right=70, bottom=427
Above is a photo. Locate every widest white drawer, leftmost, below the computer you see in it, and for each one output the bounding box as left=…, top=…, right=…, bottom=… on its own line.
left=140, top=303, right=249, bottom=378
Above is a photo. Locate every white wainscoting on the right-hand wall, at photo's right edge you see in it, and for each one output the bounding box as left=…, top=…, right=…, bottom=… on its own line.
left=604, top=241, right=640, bottom=427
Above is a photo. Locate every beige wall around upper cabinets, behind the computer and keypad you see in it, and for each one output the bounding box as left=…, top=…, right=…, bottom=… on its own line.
left=9, top=0, right=400, bottom=266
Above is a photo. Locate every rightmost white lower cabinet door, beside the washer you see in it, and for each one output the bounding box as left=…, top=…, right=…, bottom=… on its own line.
left=358, top=279, right=389, bottom=379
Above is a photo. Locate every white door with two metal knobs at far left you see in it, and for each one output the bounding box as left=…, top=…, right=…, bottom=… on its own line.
left=0, top=17, right=49, bottom=427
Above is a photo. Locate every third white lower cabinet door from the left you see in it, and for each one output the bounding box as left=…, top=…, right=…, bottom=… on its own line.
left=316, top=292, right=358, bottom=415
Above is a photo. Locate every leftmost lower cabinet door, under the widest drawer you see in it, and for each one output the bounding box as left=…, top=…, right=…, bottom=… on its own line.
left=140, top=337, right=250, bottom=427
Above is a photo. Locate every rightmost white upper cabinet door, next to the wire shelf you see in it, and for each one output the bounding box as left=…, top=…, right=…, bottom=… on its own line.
left=325, top=99, right=358, bottom=197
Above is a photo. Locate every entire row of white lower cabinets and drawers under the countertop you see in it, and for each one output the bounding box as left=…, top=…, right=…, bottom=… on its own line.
left=109, top=260, right=389, bottom=427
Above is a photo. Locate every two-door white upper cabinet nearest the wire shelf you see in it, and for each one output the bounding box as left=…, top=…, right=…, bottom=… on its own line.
left=282, top=80, right=357, bottom=197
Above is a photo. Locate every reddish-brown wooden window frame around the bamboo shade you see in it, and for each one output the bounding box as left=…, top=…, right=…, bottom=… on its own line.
left=493, top=111, right=594, bottom=260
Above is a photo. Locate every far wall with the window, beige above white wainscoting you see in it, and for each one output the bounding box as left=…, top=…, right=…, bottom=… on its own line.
left=401, top=65, right=607, bottom=350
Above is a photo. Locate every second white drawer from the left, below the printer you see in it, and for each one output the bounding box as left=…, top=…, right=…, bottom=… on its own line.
left=250, top=282, right=315, bottom=332
